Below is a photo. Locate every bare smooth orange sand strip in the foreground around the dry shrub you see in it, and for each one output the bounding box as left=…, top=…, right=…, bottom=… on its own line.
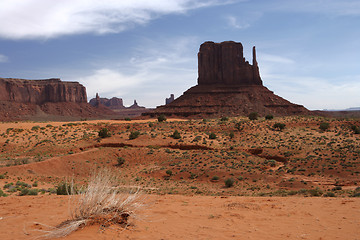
left=0, top=195, right=360, bottom=240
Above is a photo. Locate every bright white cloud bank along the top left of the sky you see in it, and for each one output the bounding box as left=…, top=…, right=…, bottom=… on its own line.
left=0, top=0, right=228, bottom=39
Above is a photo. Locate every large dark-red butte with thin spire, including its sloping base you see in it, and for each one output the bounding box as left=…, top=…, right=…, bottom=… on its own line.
left=143, top=41, right=310, bottom=117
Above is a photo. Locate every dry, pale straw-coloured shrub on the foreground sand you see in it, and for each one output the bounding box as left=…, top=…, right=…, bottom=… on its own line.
left=42, top=169, right=143, bottom=239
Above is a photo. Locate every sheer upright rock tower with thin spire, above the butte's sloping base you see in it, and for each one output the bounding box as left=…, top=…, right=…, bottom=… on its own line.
left=198, top=41, right=262, bottom=85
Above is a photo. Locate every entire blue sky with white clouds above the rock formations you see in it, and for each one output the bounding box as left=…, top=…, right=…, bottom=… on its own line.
left=0, top=0, right=360, bottom=110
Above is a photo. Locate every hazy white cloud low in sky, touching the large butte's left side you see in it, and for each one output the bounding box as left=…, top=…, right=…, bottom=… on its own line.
left=79, top=37, right=197, bottom=107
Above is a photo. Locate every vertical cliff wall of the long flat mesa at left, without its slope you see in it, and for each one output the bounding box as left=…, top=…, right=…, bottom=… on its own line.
left=0, top=78, right=87, bottom=105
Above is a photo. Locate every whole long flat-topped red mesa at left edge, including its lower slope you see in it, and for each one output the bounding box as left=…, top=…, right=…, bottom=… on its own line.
left=0, top=78, right=112, bottom=121
